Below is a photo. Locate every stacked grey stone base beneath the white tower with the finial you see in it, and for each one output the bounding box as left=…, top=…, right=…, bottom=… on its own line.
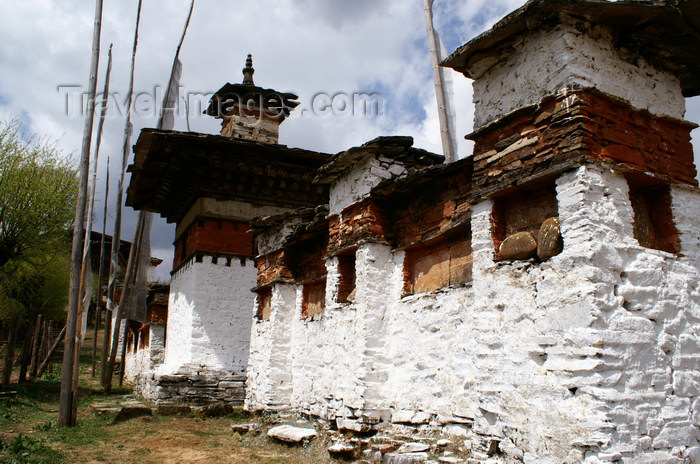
left=134, top=367, right=246, bottom=406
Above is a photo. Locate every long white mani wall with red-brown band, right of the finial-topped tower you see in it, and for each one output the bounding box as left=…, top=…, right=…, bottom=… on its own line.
left=246, top=2, right=700, bottom=463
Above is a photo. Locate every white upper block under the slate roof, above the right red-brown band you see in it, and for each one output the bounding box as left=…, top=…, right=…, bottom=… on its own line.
left=473, top=24, right=685, bottom=128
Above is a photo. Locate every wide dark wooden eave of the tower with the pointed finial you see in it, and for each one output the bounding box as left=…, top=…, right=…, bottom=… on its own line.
left=126, top=129, right=330, bottom=222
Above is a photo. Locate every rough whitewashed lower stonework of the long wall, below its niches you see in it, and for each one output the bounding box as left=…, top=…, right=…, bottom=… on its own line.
left=248, top=167, right=700, bottom=464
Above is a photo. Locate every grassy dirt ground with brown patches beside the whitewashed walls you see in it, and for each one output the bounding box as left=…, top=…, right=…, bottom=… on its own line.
left=0, top=328, right=330, bottom=464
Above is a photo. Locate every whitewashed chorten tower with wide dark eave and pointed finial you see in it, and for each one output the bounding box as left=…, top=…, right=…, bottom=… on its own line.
left=127, top=55, right=328, bottom=403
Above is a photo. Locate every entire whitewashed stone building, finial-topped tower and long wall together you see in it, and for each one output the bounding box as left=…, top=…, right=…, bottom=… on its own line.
left=130, top=0, right=700, bottom=464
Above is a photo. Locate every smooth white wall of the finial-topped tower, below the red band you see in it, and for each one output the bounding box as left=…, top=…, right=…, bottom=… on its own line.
left=159, top=256, right=257, bottom=374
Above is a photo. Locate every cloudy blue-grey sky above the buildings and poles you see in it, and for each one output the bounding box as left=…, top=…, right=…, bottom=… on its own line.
left=0, top=0, right=700, bottom=279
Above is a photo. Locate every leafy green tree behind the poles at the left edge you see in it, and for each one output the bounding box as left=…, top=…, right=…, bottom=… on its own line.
left=0, top=120, right=78, bottom=385
